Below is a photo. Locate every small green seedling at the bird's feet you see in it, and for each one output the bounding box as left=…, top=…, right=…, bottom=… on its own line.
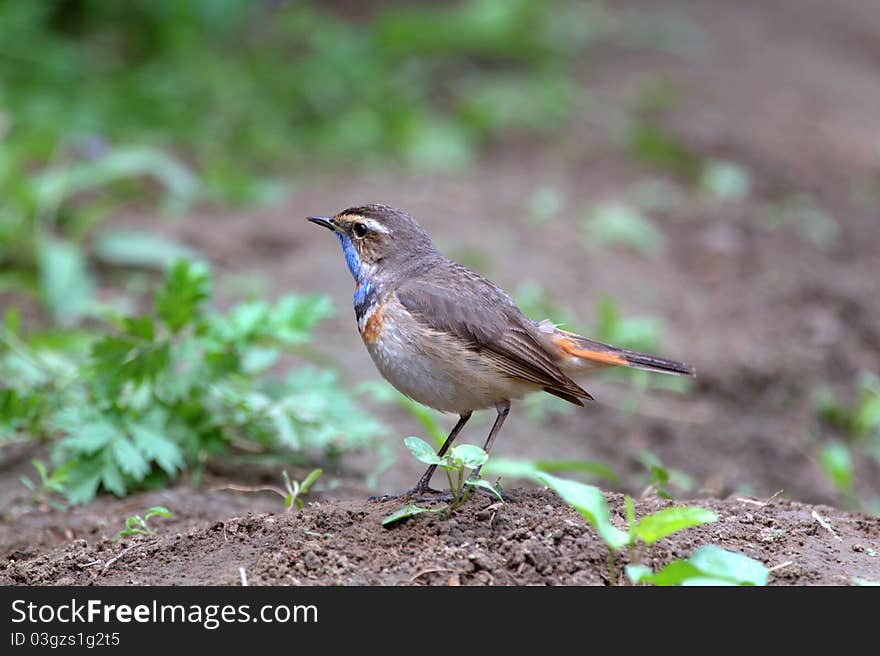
left=382, top=437, right=502, bottom=526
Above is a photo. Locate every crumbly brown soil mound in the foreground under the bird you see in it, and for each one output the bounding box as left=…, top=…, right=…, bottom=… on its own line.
left=0, top=490, right=880, bottom=585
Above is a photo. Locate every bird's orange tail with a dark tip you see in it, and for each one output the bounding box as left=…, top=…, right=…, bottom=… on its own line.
left=539, top=322, right=695, bottom=376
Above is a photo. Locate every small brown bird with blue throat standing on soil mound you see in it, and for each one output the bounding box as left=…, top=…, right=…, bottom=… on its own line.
left=306, top=203, right=695, bottom=496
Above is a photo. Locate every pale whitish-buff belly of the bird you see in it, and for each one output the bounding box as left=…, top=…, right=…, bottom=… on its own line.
left=361, top=302, right=539, bottom=414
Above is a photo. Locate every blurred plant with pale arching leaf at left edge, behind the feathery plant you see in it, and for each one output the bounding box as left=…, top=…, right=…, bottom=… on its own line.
left=0, top=142, right=200, bottom=325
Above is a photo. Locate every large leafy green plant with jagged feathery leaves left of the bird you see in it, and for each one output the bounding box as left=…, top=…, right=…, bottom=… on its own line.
left=0, top=261, right=380, bottom=503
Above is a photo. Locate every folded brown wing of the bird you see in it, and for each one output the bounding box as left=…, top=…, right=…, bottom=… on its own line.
left=396, top=264, right=593, bottom=405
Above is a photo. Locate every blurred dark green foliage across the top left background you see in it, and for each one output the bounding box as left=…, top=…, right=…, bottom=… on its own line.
left=0, top=0, right=604, bottom=201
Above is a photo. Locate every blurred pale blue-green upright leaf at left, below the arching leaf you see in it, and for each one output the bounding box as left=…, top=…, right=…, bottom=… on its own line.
left=37, top=237, right=95, bottom=325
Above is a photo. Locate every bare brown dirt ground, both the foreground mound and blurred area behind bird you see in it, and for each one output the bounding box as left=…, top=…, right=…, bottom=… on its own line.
left=0, top=0, right=880, bottom=585
